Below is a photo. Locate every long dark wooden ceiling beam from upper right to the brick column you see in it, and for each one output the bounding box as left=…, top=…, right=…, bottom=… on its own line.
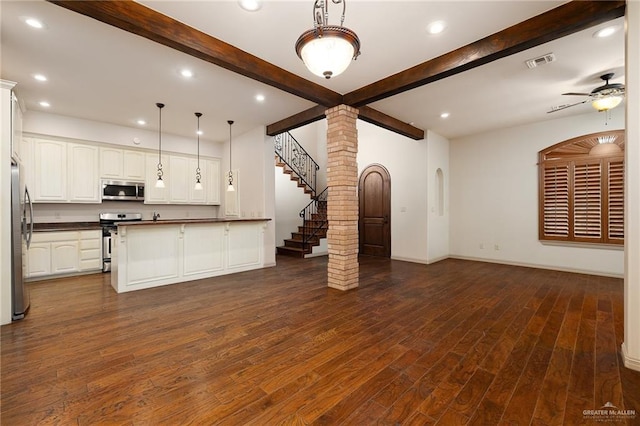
left=343, top=0, right=625, bottom=108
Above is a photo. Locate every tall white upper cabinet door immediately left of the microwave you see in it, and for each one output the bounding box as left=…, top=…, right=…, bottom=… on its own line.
left=67, top=143, right=102, bottom=203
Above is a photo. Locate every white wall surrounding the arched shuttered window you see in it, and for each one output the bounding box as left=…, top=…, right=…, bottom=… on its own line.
left=450, top=108, right=624, bottom=276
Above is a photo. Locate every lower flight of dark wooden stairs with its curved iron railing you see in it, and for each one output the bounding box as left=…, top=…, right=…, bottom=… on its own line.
left=277, top=189, right=329, bottom=257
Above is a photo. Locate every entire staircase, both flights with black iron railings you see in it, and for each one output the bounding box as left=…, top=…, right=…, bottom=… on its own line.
left=274, top=132, right=328, bottom=257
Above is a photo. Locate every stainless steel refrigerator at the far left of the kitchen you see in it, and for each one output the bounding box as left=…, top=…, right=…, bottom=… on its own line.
left=11, top=160, right=33, bottom=320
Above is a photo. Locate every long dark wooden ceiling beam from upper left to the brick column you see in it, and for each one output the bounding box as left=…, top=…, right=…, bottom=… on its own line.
left=49, top=0, right=342, bottom=107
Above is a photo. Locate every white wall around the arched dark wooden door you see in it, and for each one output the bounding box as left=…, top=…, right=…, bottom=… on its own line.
left=357, top=120, right=435, bottom=263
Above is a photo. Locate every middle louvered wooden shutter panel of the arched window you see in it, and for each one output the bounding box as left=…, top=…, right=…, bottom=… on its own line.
left=573, top=162, right=602, bottom=239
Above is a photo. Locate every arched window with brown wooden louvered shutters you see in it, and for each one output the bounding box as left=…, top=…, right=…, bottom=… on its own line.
left=538, top=130, right=625, bottom=244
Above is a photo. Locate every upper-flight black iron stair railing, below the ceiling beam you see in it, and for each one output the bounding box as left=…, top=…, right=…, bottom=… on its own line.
left=274, top=132, right=320, bottom=197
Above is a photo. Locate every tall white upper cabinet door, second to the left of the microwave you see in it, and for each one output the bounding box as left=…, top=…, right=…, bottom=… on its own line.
left=33, top=139, right=67, bottom=202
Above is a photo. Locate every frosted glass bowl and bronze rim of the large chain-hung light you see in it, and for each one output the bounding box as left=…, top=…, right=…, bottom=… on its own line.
left=296, top=26, right=360, bottom=79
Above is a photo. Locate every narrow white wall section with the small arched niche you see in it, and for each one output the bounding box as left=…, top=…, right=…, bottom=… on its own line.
left=426, top=131, right=451, bottom=263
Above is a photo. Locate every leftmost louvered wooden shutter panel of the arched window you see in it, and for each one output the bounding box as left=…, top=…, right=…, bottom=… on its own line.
left=542, top=164, right=569, bottom=237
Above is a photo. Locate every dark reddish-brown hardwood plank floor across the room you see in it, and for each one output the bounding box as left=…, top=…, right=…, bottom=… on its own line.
left=0, top=257, right=640, bottom=425
